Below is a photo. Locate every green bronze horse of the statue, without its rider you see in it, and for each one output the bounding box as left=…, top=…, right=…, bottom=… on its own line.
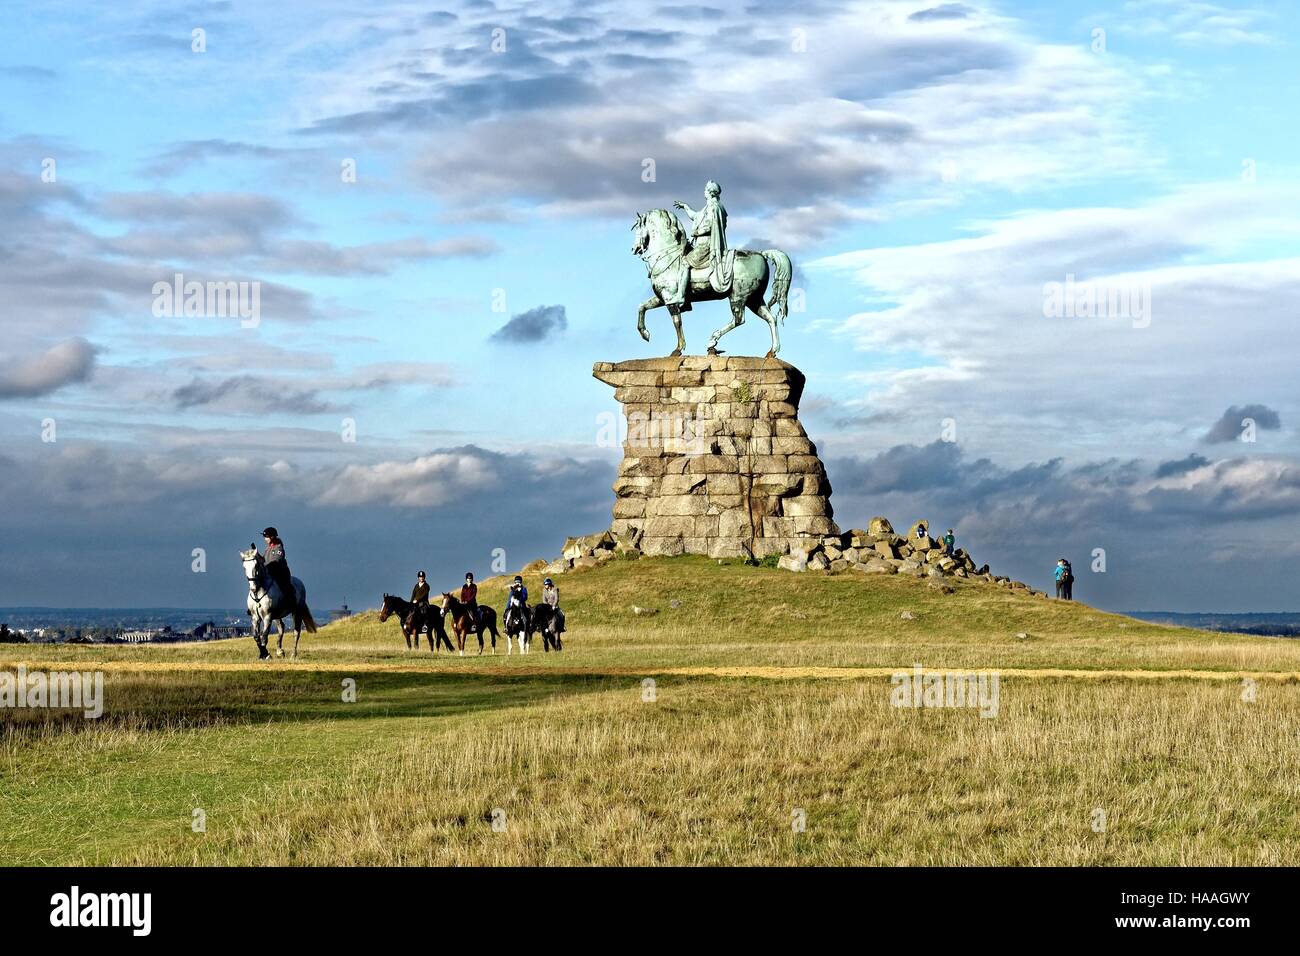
left=632, top=209, right=792, bottom=359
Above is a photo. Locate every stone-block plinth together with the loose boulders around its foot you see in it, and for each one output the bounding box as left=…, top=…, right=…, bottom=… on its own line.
left=512, top=355, right=1040, bottom=593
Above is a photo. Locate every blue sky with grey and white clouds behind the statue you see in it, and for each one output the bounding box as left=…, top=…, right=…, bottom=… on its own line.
left=0, top=0, right=1300, bottom=611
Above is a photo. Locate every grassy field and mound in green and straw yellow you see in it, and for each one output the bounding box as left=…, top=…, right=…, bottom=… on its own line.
left=0, top=558, right=1300, bottom=865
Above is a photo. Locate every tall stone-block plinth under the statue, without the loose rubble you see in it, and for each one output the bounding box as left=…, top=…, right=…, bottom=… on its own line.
left=592, top=355, right=840, bottom=558
